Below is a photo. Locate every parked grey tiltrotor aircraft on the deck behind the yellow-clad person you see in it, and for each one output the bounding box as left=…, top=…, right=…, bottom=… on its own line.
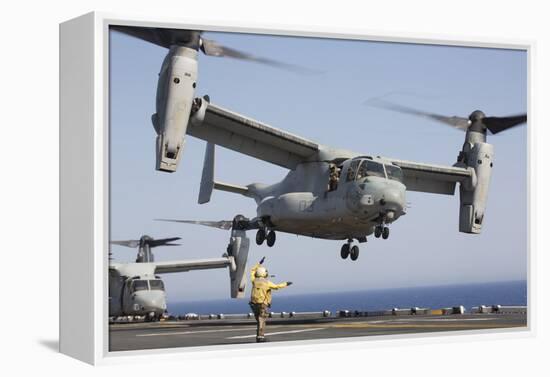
left=109, top=231, right=248, bottom=321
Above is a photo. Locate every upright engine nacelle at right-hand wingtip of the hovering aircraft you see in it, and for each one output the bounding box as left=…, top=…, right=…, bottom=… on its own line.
left=457, top=131, right=494, bottom=233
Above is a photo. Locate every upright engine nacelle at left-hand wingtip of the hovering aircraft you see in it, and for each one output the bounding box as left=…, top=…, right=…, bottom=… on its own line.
left=152, top=46, right=198, bottom=172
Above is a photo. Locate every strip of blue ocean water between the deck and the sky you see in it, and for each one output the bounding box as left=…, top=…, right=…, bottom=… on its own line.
left=168, top=281, right=527, bottom=315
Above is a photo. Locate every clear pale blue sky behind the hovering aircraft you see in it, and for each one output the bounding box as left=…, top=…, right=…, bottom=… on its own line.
left=110, top=28, right=528, bottom=303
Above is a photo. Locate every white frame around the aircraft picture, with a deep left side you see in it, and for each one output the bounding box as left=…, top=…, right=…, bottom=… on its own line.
left=60, top=12, right=534, bottom=364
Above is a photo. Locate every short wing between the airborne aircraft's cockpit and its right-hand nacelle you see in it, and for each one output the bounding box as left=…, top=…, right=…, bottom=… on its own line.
left=390, top=159, right=474, bottom=195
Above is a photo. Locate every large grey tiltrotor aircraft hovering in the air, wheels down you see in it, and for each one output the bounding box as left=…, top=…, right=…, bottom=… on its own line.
left=116, top=27, right=527, bottom=260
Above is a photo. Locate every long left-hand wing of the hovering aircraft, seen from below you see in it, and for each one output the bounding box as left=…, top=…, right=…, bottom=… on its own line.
left=187, top=101, right=319, bottom=169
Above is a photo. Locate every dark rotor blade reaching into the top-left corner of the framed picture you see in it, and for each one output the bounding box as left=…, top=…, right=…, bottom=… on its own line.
left=111, top=25, right=201, bottom=49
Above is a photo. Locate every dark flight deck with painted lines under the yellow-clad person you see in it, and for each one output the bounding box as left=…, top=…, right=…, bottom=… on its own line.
left=109, top=309, right=527, bottom=351
